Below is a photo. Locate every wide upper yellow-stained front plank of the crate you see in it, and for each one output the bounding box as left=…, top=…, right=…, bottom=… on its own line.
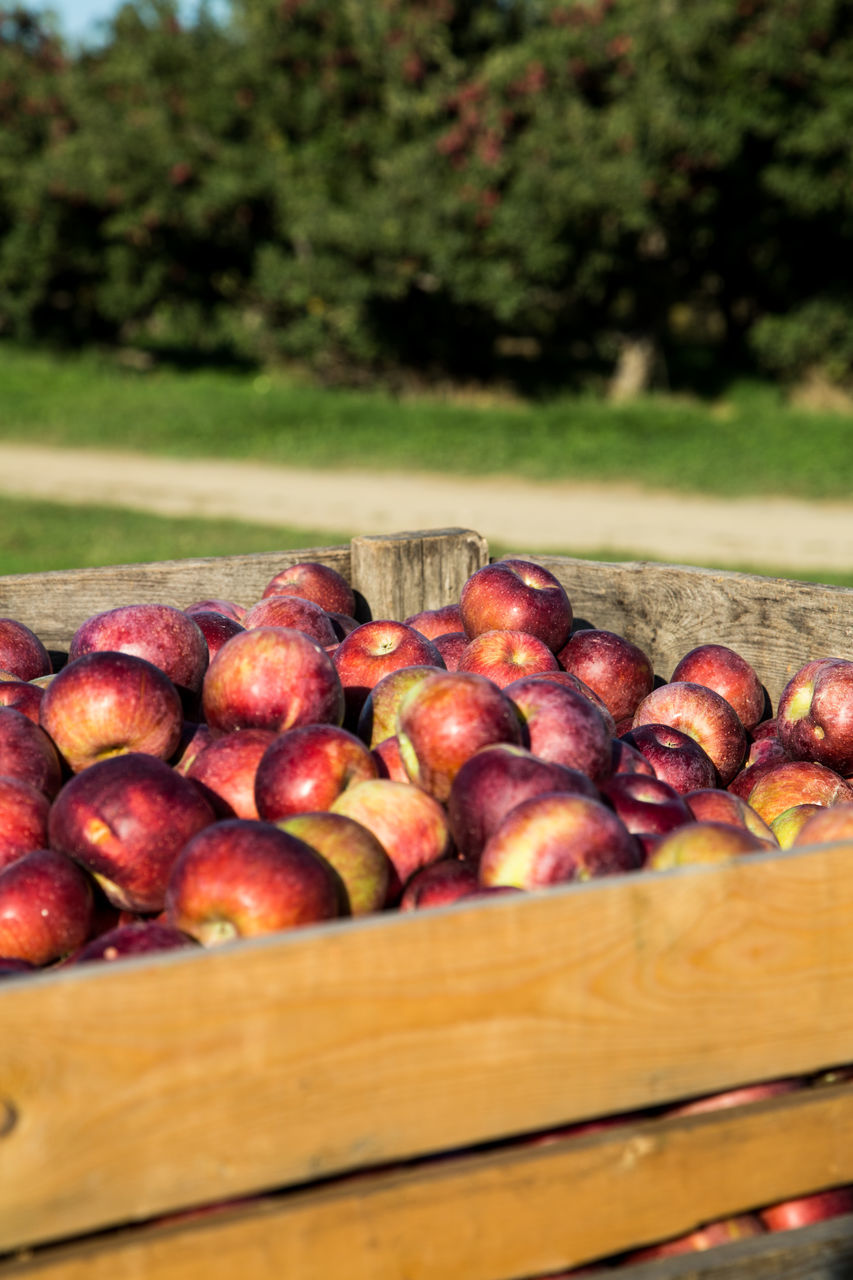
left=0, top=844, right=853, bottom=1249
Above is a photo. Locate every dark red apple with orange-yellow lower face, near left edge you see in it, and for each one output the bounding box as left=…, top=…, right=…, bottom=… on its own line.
left=38, top=652, right=183, bottom=773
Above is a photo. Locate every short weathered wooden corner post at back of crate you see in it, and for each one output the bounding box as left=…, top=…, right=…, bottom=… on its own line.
left=351, top=529, right=488, bottom=621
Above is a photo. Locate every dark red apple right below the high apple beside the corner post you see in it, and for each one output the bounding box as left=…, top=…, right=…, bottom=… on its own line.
left=557, top=627, right=654, bottom=721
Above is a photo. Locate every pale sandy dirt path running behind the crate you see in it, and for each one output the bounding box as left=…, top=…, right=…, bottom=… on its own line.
left=0, top=444, right=853, bottom=571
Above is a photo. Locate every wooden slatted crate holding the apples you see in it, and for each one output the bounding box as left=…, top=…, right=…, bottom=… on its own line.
left=0, top=530, right=853, bottom=1280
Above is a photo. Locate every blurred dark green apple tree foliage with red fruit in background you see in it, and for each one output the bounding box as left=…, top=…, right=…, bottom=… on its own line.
left=0, top=0, right=853, bottom=383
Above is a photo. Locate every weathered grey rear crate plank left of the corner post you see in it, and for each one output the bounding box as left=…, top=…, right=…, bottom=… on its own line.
left=0, top=547, right=350, bottom=652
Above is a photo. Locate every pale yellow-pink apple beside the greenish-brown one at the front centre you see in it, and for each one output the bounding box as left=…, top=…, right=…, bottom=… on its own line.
left=332, top=778, right=452, bottom=905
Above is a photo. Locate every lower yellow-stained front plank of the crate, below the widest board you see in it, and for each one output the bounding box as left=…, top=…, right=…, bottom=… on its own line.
left=0, top=1085, right=853, bottom=1280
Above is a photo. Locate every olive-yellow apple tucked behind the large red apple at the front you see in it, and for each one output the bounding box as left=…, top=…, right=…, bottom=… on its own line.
left=275, top=812, right=394, bottom=915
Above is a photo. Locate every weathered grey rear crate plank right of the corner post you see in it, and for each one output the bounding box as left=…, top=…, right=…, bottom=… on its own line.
left=514, top=556, right=853, bottom=708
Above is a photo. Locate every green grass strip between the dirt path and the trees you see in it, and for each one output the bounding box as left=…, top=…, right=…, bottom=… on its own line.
left=0, top=343, right=853, bottom=500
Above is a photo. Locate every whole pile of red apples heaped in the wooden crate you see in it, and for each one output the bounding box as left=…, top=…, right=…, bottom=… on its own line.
left=0, top=559, right=853, bottom=1254
